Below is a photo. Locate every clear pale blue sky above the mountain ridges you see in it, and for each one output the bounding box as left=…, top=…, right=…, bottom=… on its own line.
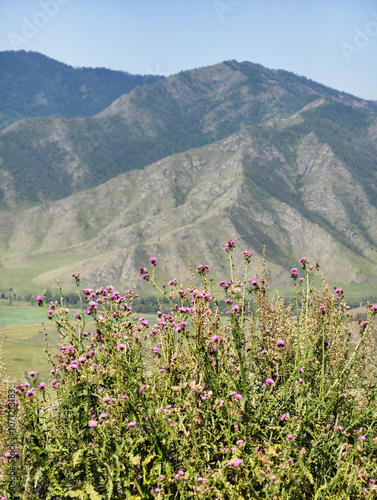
left=0, top=0, right=377, bottom=100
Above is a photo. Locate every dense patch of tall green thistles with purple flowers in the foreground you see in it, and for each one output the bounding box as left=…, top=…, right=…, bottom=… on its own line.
left=1, top=240, right=377, bottom=500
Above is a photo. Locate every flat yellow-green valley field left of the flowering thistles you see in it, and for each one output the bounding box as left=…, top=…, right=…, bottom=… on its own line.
left=0, top=306, right=156, bottom=380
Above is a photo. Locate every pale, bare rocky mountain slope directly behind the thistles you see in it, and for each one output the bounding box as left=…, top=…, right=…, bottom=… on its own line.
left=0, top=118, right=377, bottom=300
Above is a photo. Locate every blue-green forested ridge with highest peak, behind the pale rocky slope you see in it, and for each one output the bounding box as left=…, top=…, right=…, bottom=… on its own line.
left=0, top=61, right=375, bottom=209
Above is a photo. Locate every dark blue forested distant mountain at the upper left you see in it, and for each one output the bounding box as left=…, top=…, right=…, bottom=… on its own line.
left=0, top=50, right=164, bottom=130
